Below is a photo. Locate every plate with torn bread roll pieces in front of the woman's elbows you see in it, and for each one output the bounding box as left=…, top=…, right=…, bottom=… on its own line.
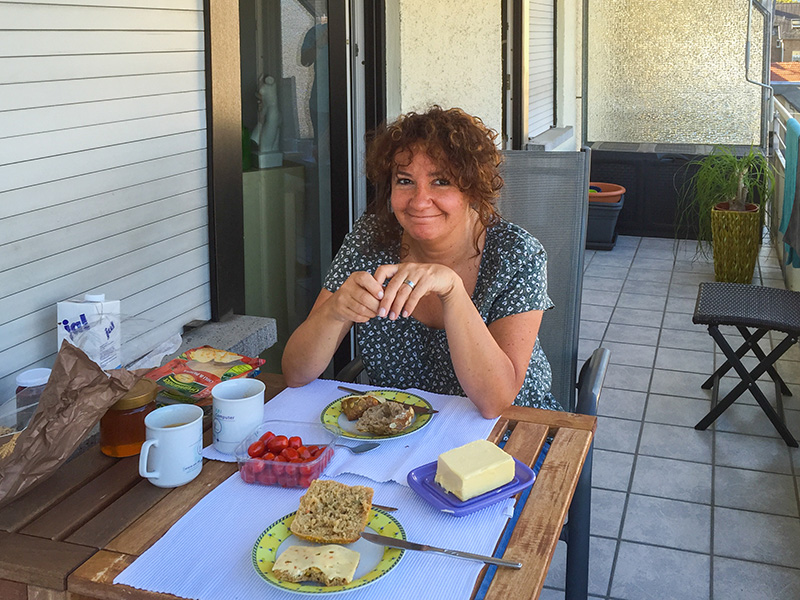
left=320, top=390, right=433, bottom=440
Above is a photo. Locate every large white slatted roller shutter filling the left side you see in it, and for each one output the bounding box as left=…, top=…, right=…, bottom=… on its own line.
left=0, top=0, right=210, bottom=402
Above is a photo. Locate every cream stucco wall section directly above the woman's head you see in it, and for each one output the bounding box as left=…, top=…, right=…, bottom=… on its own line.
left=386, top=0, right=503, bottom=131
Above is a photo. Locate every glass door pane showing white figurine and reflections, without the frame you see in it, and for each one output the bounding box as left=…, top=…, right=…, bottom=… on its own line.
left=240, top=0, right=331, bottom=372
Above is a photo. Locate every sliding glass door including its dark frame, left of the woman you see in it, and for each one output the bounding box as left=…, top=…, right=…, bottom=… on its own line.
left=239, top=0, right=383, bottom=372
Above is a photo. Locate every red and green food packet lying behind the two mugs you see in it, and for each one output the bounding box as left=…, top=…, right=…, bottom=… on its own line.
left=145, top=346, right=265, bottom=406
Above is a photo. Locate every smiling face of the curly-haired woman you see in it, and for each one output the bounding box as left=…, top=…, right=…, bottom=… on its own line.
left=391, top=149, right=477, bottom=244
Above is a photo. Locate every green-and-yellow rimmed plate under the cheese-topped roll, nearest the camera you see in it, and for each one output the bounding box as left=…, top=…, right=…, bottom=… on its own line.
left=252, top=508, right=406, bottom=594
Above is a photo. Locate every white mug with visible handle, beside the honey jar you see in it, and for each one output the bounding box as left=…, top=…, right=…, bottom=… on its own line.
left=139, top=404, right=203, bottom=488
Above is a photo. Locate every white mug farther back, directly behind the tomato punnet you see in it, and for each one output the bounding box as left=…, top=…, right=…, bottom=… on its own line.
left=211, top=378, right=266, bottom=454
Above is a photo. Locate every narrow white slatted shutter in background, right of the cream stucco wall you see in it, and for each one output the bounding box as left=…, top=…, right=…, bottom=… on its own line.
left=528, top=0, right=555, bottom=137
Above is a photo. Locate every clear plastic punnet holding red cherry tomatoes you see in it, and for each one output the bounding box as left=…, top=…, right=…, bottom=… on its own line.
left=234, top=421, right=339, bottom=488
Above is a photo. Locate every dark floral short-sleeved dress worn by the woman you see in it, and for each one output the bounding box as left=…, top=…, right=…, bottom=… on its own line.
left=323, top=215, right=563, bottom=410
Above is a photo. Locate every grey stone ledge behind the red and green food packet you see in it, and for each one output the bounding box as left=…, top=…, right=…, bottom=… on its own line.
left=172, top=315, right=278, bottom=358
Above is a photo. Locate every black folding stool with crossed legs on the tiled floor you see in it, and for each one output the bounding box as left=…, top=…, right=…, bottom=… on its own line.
left=692, top=282, right=800, bottom=448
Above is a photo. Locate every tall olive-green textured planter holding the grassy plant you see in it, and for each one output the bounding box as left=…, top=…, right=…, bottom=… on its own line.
left=711, top=202, right=761, bottom=283
